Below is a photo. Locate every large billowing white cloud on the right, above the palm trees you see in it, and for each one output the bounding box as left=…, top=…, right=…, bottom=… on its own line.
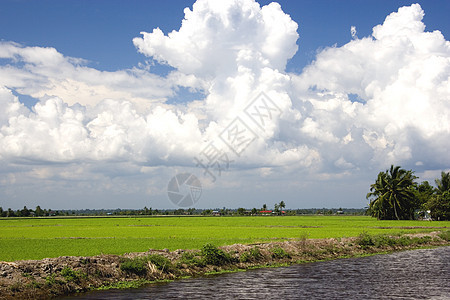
left=293, top=4, right=450, bottom=166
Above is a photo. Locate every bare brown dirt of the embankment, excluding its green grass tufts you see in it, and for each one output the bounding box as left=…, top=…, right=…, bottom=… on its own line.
left=0, top=232, right=449, bottom=299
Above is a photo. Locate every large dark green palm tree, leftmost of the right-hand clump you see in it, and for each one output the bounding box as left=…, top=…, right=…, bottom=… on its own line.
left=366, top=165, right=416, bottom=220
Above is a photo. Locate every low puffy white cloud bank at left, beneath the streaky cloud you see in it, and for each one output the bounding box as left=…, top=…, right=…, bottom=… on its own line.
left=0, top=88, right=201, bottom=165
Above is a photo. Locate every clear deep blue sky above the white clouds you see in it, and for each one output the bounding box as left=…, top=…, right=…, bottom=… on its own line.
left=0, top=0, right=450, bottom=72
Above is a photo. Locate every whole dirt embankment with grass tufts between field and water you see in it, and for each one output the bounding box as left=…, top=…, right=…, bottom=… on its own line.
left=0, top=232, right=450, bottom=299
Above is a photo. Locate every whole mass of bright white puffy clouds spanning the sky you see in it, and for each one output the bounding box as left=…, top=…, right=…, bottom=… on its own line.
left=0, top=0, right=450, bottom=209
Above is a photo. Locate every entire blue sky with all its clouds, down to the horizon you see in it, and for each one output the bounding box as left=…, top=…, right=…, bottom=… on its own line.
left=0, top=0, right=450, bottom=209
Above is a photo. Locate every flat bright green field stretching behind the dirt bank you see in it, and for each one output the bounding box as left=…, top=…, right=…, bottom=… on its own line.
left=0, top=216, right=450, bottom=261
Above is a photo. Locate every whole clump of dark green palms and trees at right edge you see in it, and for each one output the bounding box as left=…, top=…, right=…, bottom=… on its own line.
left=366, top=165, right=450, bottom=220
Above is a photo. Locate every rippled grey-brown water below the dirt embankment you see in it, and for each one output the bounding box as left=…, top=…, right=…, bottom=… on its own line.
left=65, top=247, right=450, bottom=299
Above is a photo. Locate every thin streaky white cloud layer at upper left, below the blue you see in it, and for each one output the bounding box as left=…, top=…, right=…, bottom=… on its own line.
left=0, top=42, right=175, bottom=108
